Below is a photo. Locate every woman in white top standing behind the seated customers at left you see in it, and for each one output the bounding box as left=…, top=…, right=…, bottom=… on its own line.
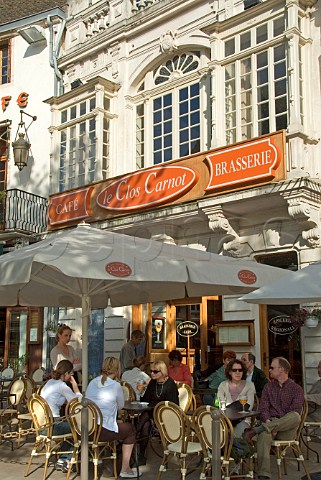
left=50, top=325, right=81, bottom=381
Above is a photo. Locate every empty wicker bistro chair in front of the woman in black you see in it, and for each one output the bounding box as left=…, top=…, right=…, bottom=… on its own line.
left=154, top=401, right=202, bottom=480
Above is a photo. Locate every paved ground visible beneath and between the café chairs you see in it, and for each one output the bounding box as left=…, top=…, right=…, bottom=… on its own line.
left=0, top=437, right=321, bottom=480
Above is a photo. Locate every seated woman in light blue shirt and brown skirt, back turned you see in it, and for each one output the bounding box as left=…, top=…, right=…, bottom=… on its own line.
left=86, top=357, right=141, bottom=478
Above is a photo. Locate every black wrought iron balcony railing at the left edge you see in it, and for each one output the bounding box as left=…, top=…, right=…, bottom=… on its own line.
left=0, top=188, right=48, bottom=235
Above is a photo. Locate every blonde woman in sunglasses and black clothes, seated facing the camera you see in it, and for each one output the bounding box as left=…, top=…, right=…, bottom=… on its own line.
left=137, top=360, right=179, bottom=465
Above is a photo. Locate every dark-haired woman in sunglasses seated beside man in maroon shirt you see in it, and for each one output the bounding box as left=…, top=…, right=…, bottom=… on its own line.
left=217, top=359, right=255, bottom=438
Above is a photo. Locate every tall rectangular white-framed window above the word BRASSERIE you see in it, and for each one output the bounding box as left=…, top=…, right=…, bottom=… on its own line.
left=224, top=16, right=288, bottom=144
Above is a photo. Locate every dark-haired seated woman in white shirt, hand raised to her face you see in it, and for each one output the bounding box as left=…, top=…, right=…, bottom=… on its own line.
left=40, top=360, right=82, bottom=472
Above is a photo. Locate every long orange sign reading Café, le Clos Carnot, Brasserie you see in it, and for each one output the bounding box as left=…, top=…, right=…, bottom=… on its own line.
left=49, top=131, right=285, bottom=228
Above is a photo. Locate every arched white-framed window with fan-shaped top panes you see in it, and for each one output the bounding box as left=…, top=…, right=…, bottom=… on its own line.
left=136, top=52, right=205, bottom=168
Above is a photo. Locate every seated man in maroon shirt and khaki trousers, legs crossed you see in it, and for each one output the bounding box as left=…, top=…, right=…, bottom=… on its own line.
left=243, top=357, right=304, bottom=480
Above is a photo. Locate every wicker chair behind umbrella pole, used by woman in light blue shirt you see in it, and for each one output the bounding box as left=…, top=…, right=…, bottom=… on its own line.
left=66, top=398, right=117, bottom=480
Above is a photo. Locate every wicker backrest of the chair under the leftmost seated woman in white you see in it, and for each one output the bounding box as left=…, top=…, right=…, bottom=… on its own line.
left=28, top=393, right=53, bottom=438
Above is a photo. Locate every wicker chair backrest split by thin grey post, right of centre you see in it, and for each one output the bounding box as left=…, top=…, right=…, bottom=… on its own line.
left=192, top=405, right=234, bottom=460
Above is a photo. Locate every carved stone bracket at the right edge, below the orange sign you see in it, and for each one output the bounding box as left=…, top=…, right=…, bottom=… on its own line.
left=283, top=190, right=321, bottom=248
